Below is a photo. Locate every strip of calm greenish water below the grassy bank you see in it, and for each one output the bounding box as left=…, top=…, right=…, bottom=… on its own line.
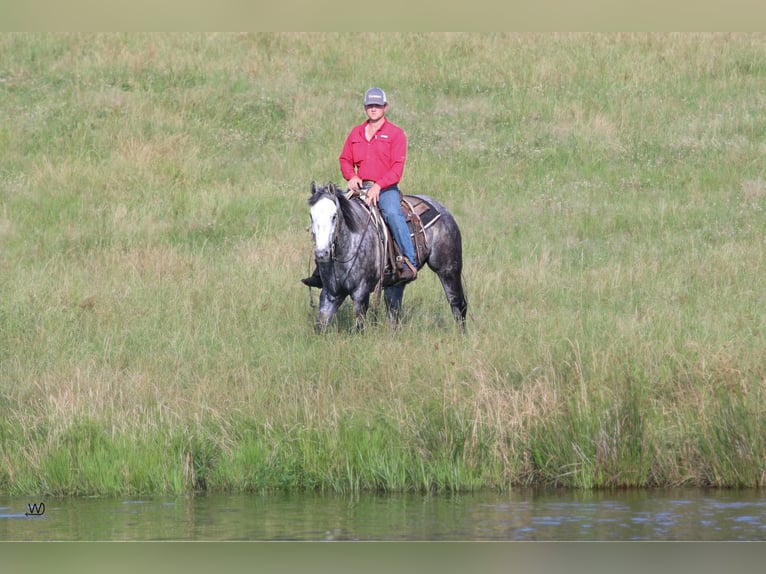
left=0, top=489, right=766, bottom=541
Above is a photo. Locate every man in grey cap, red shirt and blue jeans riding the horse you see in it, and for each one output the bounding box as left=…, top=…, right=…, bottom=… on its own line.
left=301, top=88, right=418, bottom=287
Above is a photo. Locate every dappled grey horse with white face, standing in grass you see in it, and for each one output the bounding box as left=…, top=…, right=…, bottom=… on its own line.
left=308, top=182, right=468, bottom=333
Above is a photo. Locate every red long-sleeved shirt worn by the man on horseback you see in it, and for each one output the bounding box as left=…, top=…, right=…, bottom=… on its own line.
left=338, top=119, right=407, bottom=189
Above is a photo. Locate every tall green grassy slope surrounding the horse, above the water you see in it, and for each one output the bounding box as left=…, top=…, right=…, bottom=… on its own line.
left=0, top=34, right=766, bottom=494
